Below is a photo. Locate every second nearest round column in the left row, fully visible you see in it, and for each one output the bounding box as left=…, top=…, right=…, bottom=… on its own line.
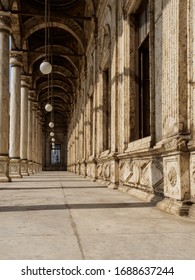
left=9, top=52, right=22, bottom=178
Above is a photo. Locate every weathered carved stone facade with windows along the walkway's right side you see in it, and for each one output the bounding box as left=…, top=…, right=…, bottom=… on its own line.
left=68, top=0, right=195, bottom=215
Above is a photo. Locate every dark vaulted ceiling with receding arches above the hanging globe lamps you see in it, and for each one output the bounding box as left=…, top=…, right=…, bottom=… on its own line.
left=1, top=0, right=96, bottom=127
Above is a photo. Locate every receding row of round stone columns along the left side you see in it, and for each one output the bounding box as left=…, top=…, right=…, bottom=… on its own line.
left=0, top=11, right=42, bottom=182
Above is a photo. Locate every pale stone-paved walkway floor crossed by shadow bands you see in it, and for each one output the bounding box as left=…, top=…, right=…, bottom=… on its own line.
left=0, top=172, right=195, bottom=260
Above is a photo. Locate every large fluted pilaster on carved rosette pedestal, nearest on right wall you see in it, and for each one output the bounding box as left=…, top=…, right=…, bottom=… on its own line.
left=158, top=0, right=190, bottom=215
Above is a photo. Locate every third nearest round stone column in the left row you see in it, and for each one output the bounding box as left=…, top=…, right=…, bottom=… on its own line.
left=20, top=76, right=29, bottom=176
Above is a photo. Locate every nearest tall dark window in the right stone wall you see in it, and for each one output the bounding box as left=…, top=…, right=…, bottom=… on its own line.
left=137, top=1, right=150, bottom=138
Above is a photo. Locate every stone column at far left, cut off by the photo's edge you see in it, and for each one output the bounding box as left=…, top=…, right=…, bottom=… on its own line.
left=0, top=11, right=11, bottom=182
